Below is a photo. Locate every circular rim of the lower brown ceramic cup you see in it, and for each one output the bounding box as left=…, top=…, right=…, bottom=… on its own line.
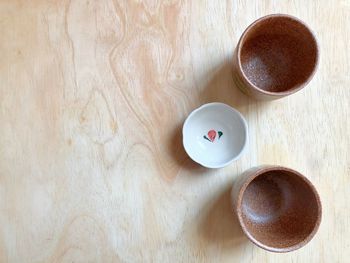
left=236, top=165, right=322, bottom=253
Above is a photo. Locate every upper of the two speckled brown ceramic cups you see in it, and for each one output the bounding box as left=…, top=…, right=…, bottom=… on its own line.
left=233, top=14, right=319, bottom=100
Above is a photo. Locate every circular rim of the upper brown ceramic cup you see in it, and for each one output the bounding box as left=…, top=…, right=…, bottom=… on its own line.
left=237, top=13, right=320, bottom=97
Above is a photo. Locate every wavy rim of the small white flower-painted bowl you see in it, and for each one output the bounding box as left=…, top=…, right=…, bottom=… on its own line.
left=182, top=102, right=248, bottom=169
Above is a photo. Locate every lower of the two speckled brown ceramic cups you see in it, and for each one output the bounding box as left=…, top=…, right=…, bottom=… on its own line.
left=231, top=165, right=322, bottom=252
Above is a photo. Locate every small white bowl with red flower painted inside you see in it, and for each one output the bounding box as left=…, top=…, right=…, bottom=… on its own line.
left=182, top=102, right=248, bottom=168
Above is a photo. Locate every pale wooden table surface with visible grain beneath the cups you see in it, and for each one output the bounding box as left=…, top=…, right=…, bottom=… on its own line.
left=0, top=0, right=350, bottom=263
